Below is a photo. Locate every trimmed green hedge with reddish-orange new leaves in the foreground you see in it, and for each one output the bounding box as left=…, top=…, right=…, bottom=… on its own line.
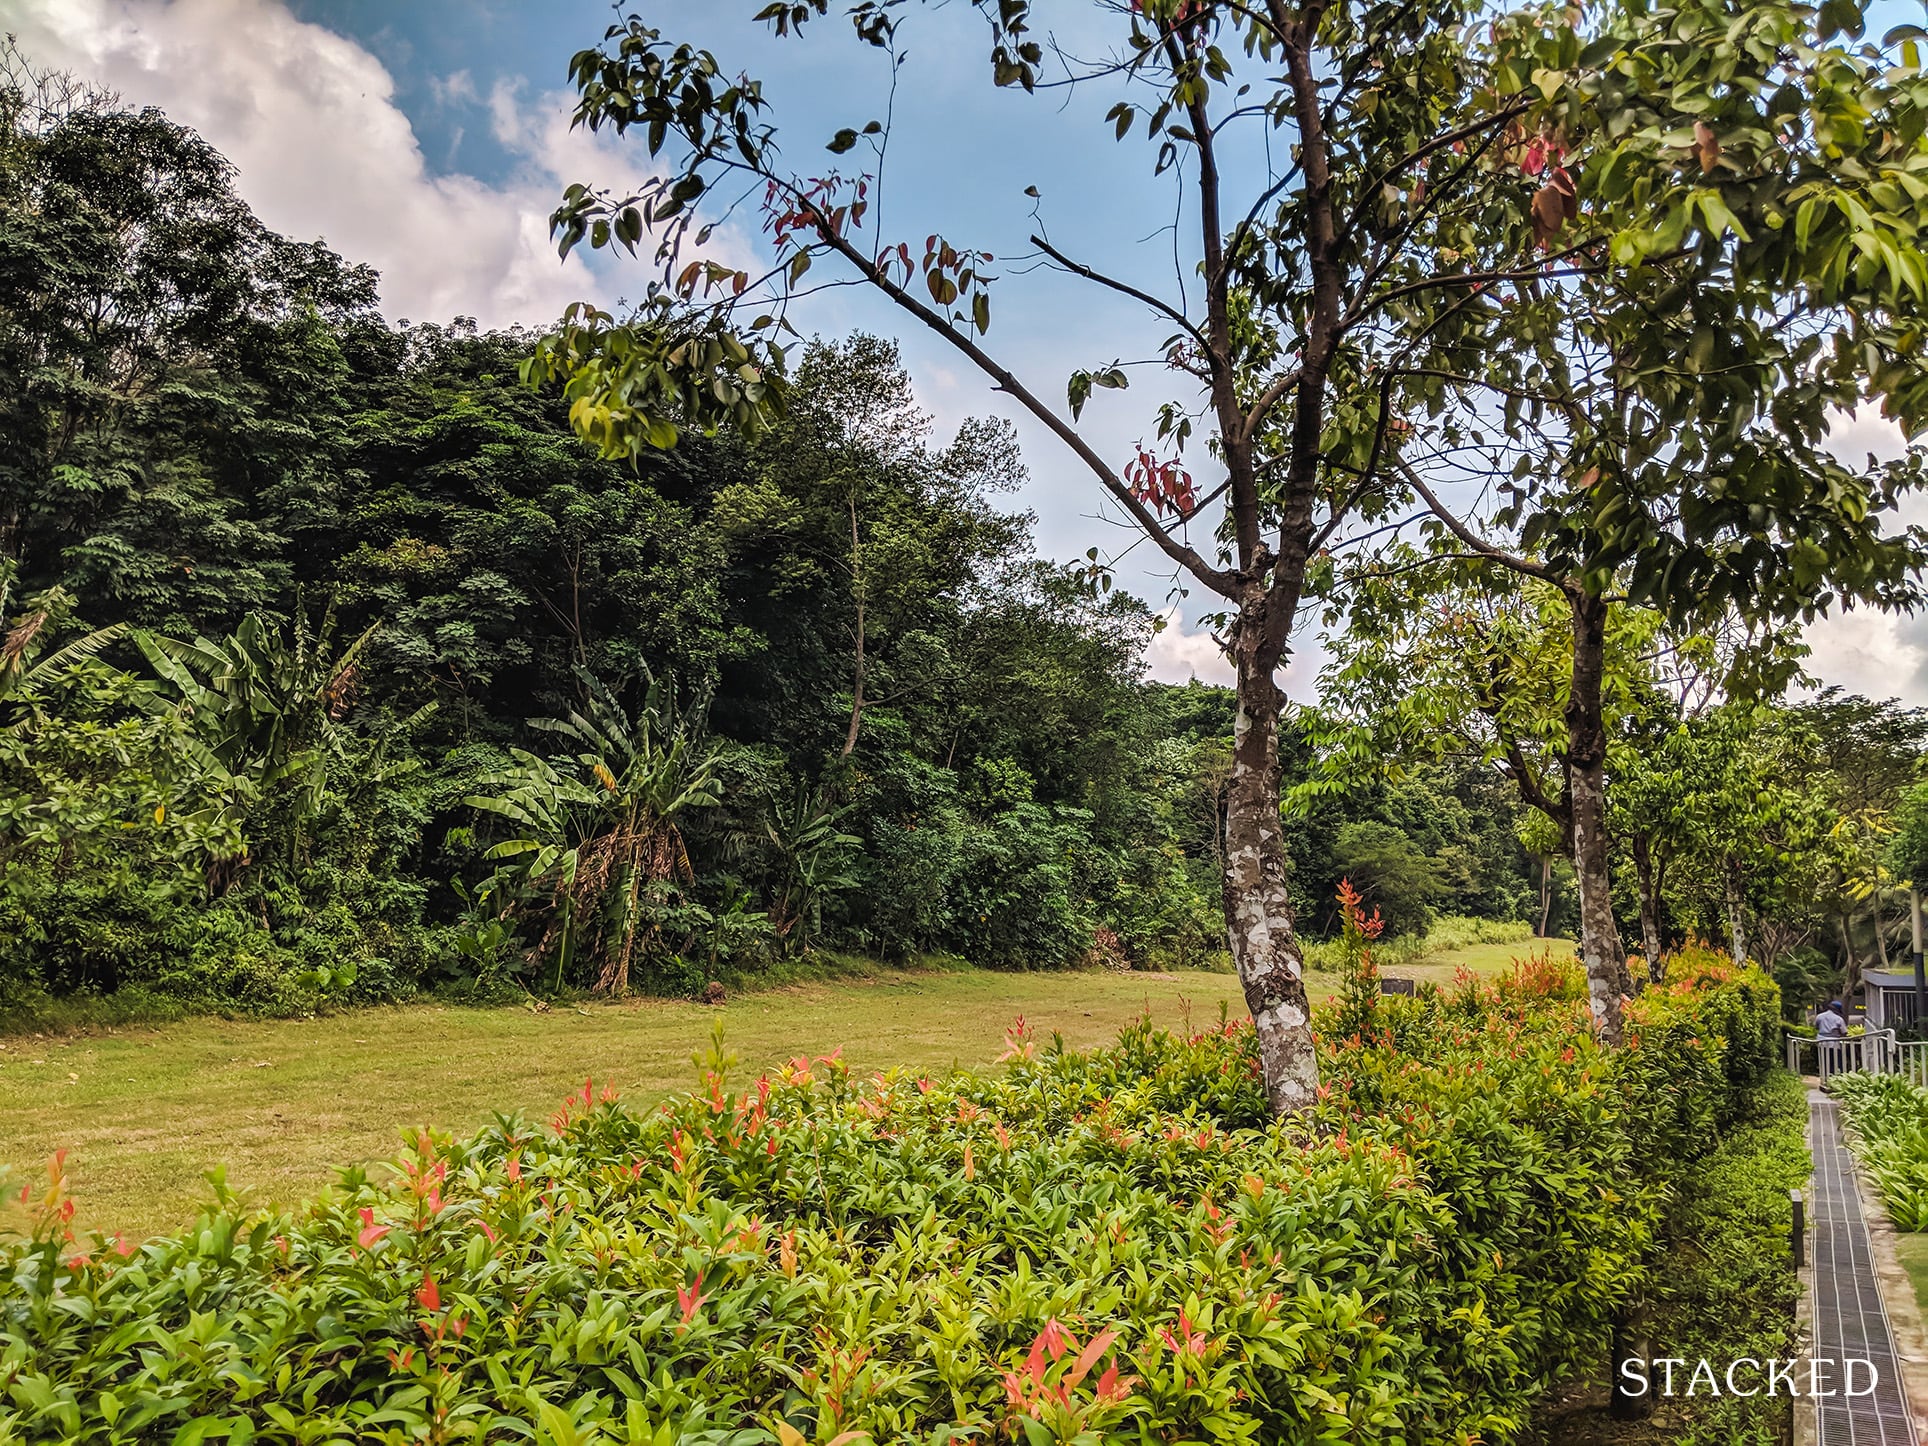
left=0, top=960, right=1780, bottom=1446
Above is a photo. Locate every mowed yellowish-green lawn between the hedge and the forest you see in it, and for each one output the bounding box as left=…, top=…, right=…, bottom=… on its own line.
left=0, top=941, right=1571, bottom=1238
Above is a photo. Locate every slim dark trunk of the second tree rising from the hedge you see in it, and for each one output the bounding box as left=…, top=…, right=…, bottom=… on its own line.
left=1566, top=584, right=1629, bottom=1049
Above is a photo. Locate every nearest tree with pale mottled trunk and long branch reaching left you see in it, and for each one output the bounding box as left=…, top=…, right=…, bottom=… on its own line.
left=532, top=0, right=1704, bottom=1112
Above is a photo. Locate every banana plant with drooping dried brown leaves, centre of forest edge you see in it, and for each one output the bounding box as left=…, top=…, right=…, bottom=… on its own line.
left=463, top=673, right=719, bottom=995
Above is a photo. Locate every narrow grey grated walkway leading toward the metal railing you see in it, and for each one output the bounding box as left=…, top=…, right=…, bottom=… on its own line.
left=1803, top=1089, right=1920, bottom=1446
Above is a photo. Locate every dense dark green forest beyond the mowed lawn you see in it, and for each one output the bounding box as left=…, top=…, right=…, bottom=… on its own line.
left=0, top=65, right=1924, bottom=1008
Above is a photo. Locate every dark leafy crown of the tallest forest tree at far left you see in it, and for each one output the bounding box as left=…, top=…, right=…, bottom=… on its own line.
left=0, top=50, right=376, bottom=630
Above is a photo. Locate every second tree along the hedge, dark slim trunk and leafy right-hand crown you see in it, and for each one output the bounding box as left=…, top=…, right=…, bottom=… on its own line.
left=1372, top=4, right=1928, bottom=1035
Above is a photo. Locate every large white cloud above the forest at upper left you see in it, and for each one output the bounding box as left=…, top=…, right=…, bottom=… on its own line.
left=0, top=0, right=678, bottom=326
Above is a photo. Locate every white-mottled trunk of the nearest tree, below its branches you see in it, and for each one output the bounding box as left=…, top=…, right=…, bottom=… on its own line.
left=1224, top=600, right=1319, bottom=1114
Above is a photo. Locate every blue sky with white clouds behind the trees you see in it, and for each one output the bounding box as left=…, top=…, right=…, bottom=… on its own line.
left=0, top=0, right=1928, bottom=704
